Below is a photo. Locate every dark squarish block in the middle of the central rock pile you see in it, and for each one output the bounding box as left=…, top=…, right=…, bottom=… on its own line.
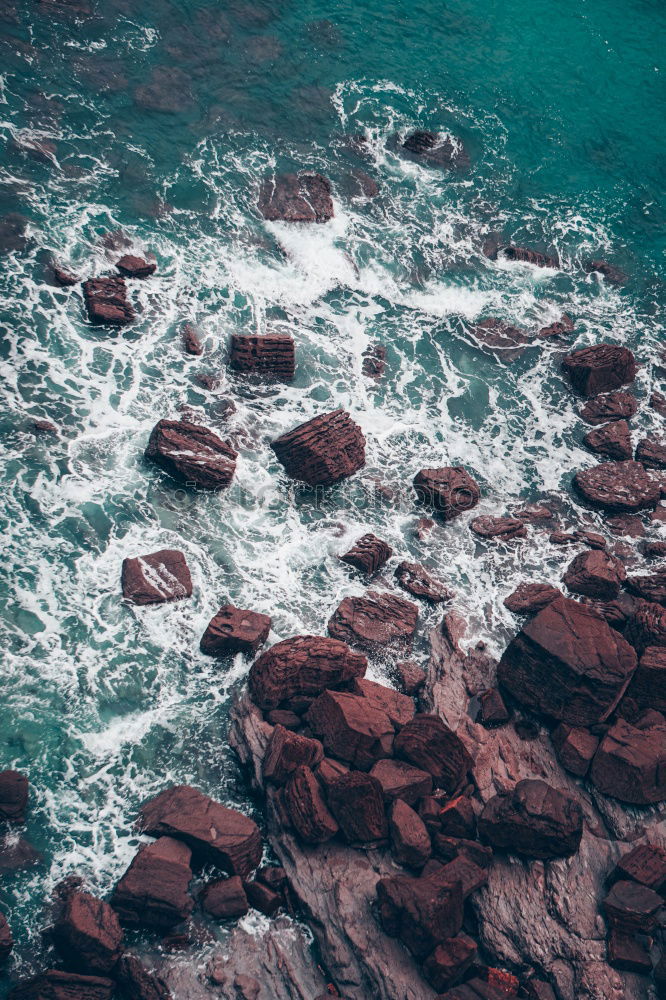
left=328, top=771, right=388, bottom=844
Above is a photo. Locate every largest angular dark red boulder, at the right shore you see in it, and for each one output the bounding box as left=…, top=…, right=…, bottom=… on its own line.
left=497, top=597, right=636, bottom=726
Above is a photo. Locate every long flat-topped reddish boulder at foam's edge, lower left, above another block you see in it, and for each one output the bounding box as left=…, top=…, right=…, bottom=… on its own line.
left=137, top=785, right=261, bottom=876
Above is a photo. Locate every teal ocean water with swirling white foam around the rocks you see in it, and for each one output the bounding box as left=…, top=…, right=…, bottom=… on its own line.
left=0, top=0, right=666, bottom=995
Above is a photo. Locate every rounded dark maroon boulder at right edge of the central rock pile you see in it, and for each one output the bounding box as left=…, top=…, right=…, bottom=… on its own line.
left=393, top=715, right=473, bottom=794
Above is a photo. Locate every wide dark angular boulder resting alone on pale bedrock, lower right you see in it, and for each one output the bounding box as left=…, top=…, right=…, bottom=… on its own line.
left=479, top=779, right=583, bottom=859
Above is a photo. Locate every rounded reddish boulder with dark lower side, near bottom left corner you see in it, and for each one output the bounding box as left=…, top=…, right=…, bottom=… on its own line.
left=53, top=892, right=123, bottom=975
